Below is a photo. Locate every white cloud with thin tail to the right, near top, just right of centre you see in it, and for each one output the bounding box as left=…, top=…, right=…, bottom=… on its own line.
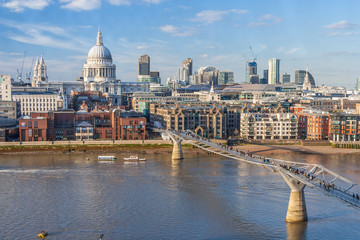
left=190, top=9, right=248, bottom=24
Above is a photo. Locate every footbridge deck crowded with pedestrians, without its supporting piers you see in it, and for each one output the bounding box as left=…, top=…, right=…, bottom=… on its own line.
left=167, top=131, right=360, bottom=207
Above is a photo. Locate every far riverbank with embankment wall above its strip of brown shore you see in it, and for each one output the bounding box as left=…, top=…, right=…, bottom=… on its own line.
left=0, top=140, right=360, bottom=156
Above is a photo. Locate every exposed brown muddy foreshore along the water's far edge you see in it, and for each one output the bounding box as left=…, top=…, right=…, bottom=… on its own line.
left=0, top=143, right=360, bottom=159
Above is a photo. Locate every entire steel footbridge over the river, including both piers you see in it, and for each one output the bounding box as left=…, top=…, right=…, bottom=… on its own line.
left=165, top=130, right=360, bottom=222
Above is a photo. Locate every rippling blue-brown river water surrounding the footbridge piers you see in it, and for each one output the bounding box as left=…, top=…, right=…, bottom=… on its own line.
left=0, top=153, right=360, bottom=240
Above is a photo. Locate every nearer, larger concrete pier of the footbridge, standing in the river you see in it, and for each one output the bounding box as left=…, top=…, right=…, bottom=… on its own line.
left=279, top=170, right=308, bottom=223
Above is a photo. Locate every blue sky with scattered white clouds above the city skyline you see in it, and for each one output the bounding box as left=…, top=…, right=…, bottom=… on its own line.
left=0, top=0, right=360, bottom=89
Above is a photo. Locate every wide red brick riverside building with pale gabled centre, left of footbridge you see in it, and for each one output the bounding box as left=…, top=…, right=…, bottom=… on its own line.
left=19, top=108, right=146, bottom=141
